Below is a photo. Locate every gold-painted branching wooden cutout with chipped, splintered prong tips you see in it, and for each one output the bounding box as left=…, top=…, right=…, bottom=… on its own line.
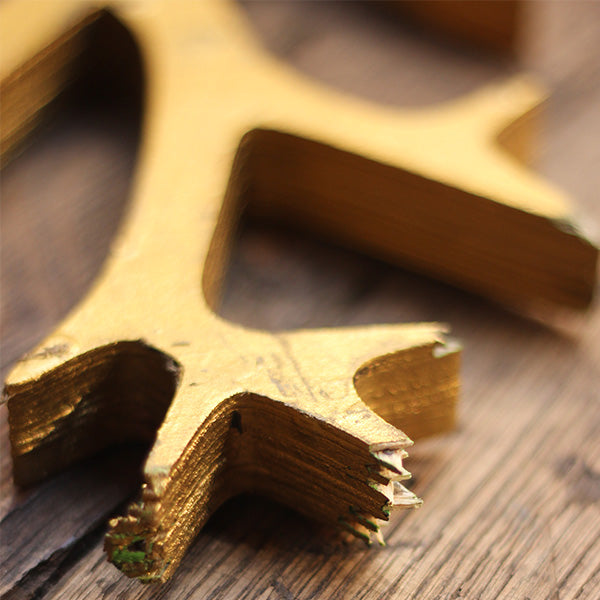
left=0, top=0, right=598, bottom=581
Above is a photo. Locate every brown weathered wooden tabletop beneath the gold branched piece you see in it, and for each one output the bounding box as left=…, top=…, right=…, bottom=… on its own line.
left=0, top=2, right=600, bottom=600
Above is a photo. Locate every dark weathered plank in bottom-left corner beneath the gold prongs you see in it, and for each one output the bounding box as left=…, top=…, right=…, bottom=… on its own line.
left=0, top=440, right=145, bottom=598
